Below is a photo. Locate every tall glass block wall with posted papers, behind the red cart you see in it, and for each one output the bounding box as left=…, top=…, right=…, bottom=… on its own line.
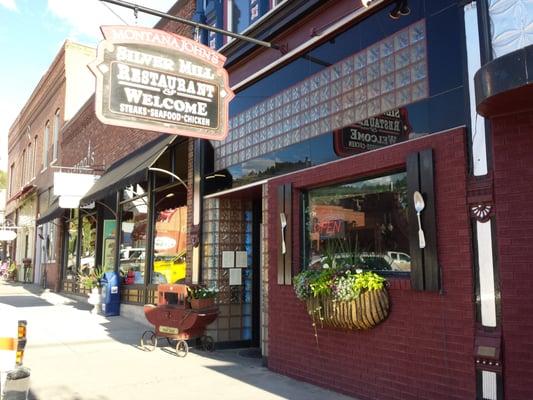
left=202, top=198, right=252, bottom=342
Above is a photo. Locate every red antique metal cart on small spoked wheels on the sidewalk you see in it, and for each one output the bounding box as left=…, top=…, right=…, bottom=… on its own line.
left=141, top=284, right=218, bottom=357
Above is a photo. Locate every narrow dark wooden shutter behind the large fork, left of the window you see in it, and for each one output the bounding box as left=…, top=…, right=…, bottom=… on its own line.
left=275, top=183, right=292, bottom=285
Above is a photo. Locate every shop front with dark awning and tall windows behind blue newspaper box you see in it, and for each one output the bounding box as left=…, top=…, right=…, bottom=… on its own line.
left=63, top=135, right=189, bottom=312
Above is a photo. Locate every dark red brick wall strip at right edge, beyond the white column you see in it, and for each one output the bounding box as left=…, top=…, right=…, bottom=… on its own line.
left=492, top=111, right=533, bottom=400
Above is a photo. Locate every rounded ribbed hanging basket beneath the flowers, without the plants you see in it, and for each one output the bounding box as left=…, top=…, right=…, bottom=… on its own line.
left=306, top=288, right=389, bottom=329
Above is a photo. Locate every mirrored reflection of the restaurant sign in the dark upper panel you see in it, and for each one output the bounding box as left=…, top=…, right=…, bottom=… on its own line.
left=333, top=108, right=411, bottom=157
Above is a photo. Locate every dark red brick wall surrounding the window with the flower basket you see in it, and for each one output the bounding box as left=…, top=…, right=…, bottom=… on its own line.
left=268, top=128, right=476, bottom=400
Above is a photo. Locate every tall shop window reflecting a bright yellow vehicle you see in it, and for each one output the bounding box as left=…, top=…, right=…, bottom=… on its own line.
left=152, top=185, right=187, bottom=283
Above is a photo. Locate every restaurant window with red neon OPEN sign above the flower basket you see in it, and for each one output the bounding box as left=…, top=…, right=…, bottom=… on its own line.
left=304, top=172, right=411, bottom=272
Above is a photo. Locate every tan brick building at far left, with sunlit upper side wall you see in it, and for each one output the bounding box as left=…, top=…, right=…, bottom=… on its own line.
left=6, top=41, right=94, bottom=287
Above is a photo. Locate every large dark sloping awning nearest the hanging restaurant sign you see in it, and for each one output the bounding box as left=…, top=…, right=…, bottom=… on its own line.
left=80, top=135, right=178, bottom=205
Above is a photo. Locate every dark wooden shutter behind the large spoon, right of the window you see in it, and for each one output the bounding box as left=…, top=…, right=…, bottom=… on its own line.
left=407, top=149, right=441, bottom=291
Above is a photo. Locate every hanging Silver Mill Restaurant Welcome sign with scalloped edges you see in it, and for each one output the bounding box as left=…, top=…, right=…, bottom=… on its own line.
left=89, top=26, right=234, bottom=140
